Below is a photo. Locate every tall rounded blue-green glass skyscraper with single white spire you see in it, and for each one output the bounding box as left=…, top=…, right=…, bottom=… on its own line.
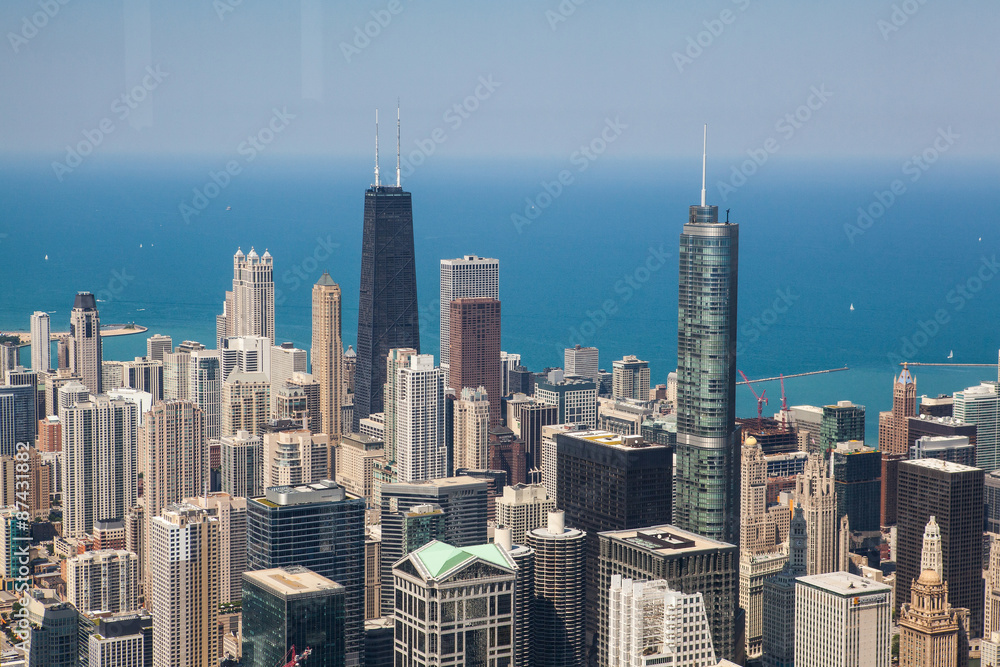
left=674, top=133, right=740, bottom=544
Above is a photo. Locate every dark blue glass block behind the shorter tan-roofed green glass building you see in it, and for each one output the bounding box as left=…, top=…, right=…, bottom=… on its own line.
left=247, top=480, right=365, bottom=665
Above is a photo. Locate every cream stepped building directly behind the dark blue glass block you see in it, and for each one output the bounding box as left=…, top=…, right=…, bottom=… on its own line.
left=264, top=430, right=330, bottom=489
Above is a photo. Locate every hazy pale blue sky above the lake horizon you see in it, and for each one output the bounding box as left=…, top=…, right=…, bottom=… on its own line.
left=0, top=0, right=1000, bottom=160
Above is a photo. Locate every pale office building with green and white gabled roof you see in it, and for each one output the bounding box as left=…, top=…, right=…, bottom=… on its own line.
left=392, top=541, right=516, bottom=665
